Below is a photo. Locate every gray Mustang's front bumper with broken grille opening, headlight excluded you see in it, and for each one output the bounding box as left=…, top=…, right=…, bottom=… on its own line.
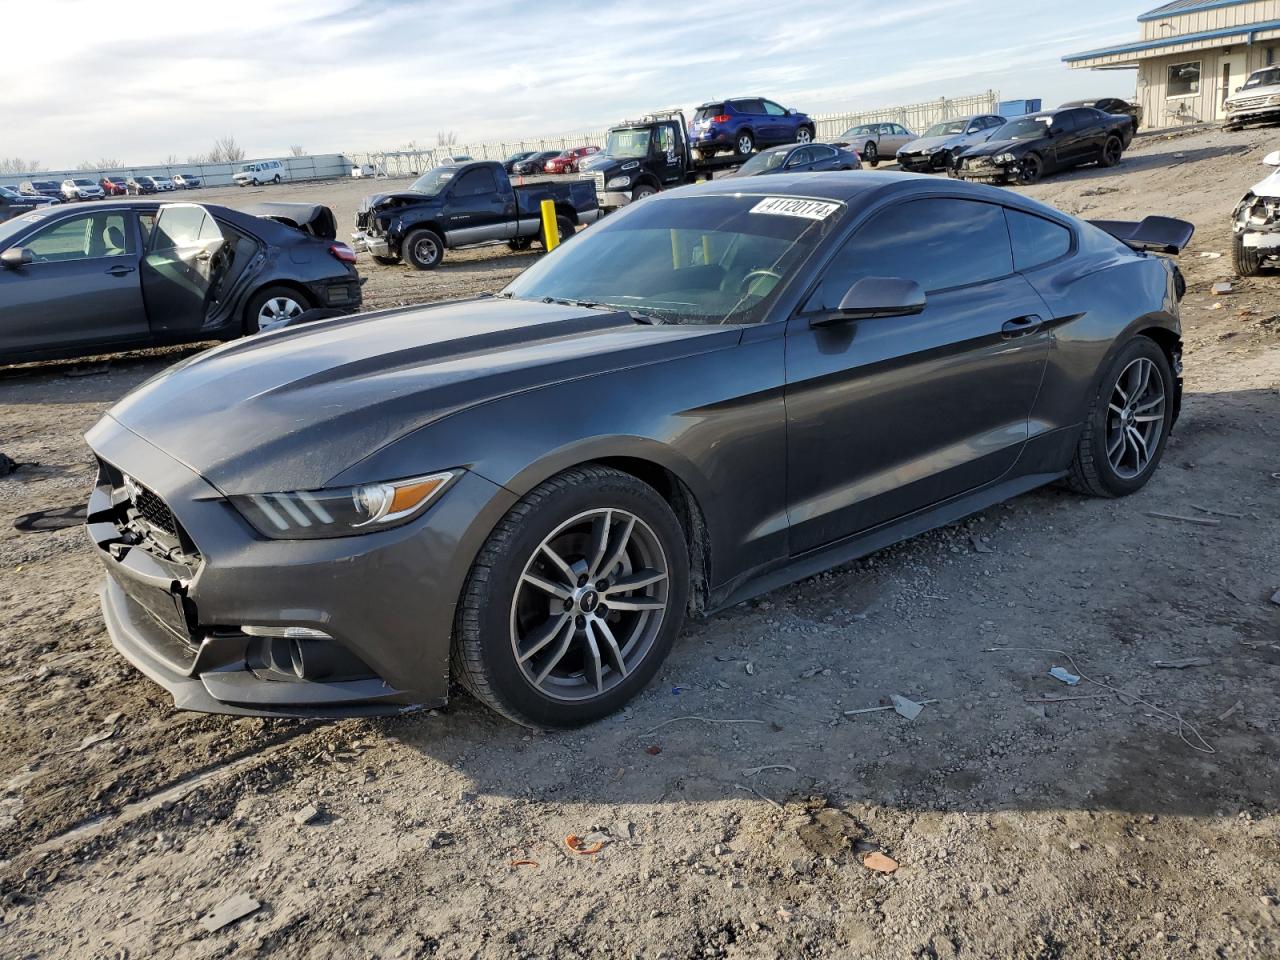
left=87, top=417, right=515, bottom=717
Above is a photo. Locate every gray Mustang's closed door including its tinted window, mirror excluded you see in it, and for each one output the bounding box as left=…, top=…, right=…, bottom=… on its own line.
left=786, top=197, right=1048, bottom=553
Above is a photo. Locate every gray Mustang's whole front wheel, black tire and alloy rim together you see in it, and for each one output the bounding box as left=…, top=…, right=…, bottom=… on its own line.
left=452, top=465, right=689, bottom=727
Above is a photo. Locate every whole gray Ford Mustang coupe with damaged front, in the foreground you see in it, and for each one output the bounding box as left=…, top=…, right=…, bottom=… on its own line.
left=87, top=173, right=1192, bottom=727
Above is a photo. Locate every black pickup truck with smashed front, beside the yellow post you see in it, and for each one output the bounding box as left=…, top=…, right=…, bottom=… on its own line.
left=351, top=160, right=600, bottom=270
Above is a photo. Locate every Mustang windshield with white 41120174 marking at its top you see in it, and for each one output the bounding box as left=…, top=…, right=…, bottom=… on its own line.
left=503, top=195, right=845, bottom=324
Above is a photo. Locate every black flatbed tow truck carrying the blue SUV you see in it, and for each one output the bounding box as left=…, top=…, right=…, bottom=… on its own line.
left=579, top=110, right=746, bottom=211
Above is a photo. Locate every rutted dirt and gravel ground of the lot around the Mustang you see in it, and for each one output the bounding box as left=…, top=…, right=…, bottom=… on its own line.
left=0, top=131, right=1280, bottom=960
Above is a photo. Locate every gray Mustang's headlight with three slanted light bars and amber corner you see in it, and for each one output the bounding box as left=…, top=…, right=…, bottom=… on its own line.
left=230, top=471, right=456, bottom=540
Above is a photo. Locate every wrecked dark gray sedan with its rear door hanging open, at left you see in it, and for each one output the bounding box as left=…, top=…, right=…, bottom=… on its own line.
left=0, top=198, right=361, bottom=364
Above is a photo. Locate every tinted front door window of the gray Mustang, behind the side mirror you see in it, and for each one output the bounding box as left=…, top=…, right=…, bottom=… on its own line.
left=805, top=197, right=1014, bottom=312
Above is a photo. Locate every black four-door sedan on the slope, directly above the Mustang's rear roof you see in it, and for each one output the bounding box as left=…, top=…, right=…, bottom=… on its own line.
left=954, top=106, right=1133, bottom=184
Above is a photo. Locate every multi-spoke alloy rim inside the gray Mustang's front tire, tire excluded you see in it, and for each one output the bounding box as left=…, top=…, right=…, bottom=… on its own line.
left=511, top=508, right=669, bottom=700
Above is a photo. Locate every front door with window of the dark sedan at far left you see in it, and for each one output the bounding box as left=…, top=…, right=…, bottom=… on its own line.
left=0, top=211, right=147, bottom=355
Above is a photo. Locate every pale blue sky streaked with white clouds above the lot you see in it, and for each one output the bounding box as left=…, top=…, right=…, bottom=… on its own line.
left=0, top=0, right=1156, bottom=168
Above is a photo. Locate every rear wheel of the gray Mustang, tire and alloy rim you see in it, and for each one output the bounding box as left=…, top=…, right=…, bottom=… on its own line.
left=1066, top=337, right=1176, bottom=497
